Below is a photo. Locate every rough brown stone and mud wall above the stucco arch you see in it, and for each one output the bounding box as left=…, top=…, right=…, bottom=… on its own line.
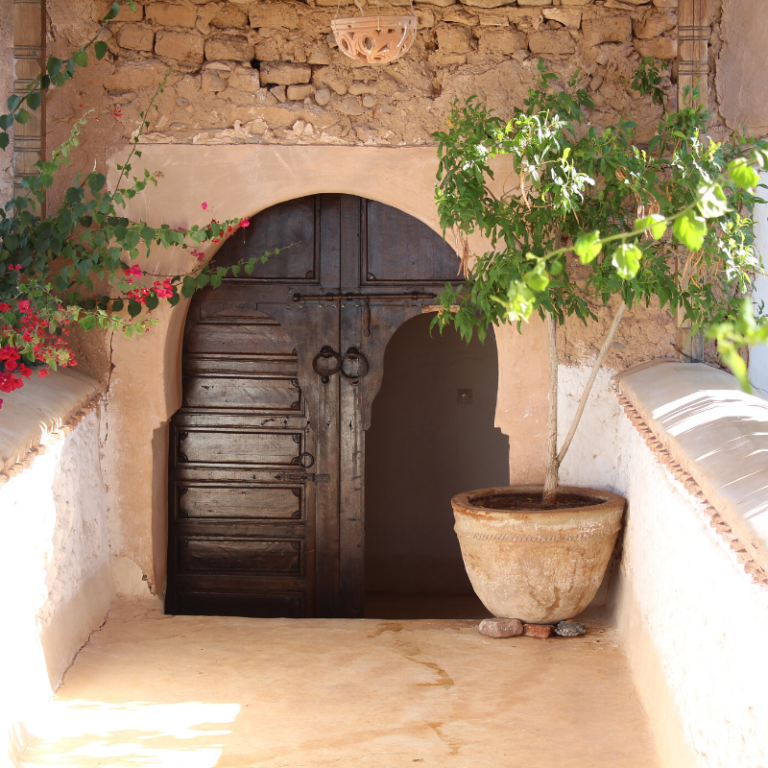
left=48, top=0, right=677, bottom=158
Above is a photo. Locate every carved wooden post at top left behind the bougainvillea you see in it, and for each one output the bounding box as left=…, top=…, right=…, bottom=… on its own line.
left=13, top=0, right=45, bottom=204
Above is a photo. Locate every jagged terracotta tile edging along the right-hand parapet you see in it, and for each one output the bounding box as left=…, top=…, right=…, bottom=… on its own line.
left=618, top=394, right=768, bottom=586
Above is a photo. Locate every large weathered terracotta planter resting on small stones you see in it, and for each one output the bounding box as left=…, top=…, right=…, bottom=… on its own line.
left=451, top=486, right=625, bottom=624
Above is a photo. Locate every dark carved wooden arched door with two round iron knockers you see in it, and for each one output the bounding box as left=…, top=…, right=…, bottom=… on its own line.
left=166, top=195, right=458, bottom=617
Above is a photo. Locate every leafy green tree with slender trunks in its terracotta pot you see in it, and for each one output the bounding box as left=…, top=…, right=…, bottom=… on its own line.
left=434, top=59, right=768, bottom=623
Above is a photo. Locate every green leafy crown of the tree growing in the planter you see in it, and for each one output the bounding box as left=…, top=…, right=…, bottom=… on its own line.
left=434, top=60, right=768, bottom=352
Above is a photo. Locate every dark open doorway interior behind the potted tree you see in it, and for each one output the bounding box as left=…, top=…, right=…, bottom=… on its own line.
left=365, top=314, right=509, bottom=619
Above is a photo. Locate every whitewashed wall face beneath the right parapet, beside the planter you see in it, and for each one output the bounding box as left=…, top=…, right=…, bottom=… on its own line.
left=559, top=367, right=768, bottom=768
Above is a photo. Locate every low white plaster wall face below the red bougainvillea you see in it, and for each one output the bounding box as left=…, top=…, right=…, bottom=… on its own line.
left=0, top=404, right=114, bottom=765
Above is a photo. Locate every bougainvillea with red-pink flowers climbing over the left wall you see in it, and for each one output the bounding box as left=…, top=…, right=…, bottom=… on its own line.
left=0, top=2, right=277, bottom=405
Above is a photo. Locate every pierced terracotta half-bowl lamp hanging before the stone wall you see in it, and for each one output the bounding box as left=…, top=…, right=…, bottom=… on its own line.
left=331, top=14, right=417, bottom=64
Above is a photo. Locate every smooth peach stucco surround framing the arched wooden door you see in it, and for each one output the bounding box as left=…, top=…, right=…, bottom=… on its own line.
left=106, top=144, right=548, bottom=595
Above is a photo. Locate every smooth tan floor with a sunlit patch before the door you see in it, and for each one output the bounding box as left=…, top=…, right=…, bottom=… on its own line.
left=23, top=603, right=658, bottom=768
